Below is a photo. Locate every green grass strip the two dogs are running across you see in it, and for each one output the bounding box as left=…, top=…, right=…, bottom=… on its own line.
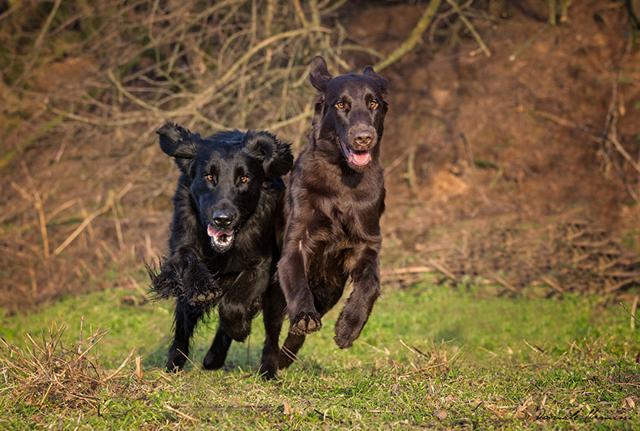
left=0, top=282, right=640, bottom=430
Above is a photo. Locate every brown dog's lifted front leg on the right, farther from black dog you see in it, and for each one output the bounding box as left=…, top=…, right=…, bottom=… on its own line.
left=334, top=246, right=380, bottom=349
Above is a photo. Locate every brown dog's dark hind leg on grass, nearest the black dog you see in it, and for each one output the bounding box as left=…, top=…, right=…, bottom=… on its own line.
left=259, top=282, right=287, bottom=379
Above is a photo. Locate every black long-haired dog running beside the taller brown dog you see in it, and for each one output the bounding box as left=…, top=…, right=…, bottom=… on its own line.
left=150, top=124, right=293, bottom=370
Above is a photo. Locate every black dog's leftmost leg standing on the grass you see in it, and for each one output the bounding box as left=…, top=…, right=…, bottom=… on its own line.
left=167, top=299, right=204, bottom=371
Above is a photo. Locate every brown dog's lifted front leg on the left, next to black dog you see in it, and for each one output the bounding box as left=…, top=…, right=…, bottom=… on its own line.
left=278, top=231, right=322, bottom=335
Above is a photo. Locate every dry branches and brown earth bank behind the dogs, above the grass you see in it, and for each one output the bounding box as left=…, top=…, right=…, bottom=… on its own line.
left=0, top=0, right=640, bottom=310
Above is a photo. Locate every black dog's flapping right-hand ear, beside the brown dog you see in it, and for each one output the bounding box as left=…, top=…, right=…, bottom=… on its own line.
left=246, top=132, right=293, bottom=178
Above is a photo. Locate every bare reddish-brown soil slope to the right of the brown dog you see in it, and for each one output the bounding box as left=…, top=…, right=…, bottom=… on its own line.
left=345, top=2, right=640, bottom=270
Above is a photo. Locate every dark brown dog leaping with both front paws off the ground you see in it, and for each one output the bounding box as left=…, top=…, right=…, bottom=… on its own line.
left=261, top=57, right=387, bottom=377
